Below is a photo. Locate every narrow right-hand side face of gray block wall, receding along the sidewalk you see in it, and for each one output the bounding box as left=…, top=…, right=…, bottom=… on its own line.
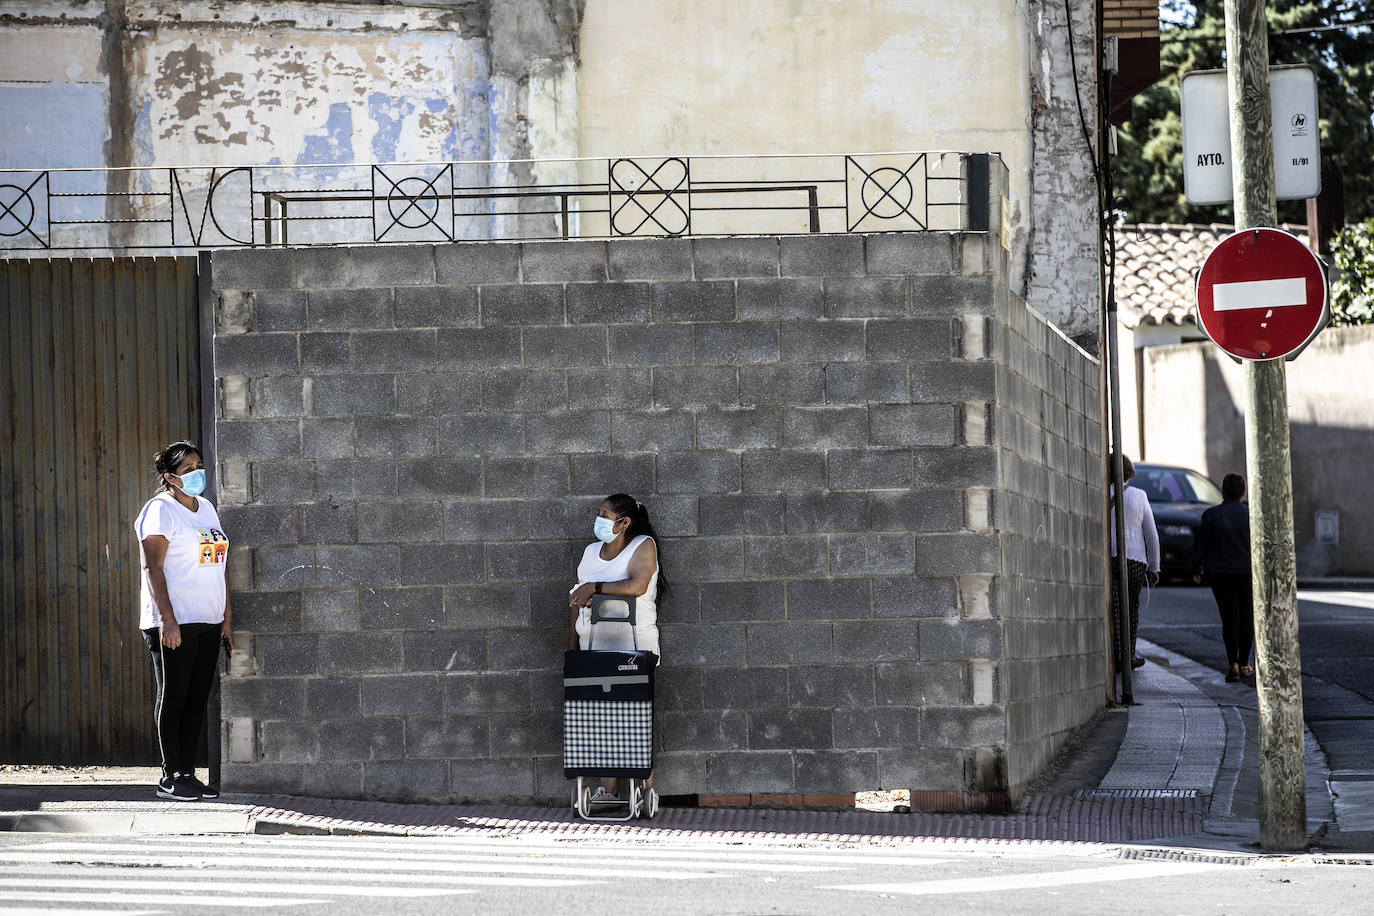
left=993, top=297, right=1107, bottom=797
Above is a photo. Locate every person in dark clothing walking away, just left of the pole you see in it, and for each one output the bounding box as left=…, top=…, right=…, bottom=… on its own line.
left=1193, top=474, right=1254, bottom=681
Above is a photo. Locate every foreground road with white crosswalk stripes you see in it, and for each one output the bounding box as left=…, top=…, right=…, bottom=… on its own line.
left=0, top=834, right=1374, bottom=916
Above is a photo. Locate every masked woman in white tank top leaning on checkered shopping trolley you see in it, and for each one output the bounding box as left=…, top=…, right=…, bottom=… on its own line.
left=567, top=493, right=668, bottom=655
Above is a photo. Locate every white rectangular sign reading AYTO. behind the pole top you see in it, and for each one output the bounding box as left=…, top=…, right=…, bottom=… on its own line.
left=1179, top=65, right=1322, bottom=205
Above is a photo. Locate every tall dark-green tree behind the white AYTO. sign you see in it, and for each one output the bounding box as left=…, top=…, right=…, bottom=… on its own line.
left=1113, top=0, right=1374, bottom=222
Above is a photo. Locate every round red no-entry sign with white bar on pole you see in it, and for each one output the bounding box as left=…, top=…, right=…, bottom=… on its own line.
left=1197, top=228, right=1330, bottom=360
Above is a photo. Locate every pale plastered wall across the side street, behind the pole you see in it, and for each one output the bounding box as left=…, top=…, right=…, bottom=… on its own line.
left=1145, top=327, right=1374, bottom=575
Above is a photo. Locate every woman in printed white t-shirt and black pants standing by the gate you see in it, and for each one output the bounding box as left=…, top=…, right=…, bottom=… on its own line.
left=133, top=442, right=234, bottom=801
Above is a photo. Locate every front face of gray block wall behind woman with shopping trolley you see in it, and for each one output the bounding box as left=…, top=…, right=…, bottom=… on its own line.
left=213, top=227, right=1096, bottom=799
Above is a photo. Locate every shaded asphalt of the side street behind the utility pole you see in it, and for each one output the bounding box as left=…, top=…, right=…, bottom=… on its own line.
left=1140, top=586, right=1374, bottom=775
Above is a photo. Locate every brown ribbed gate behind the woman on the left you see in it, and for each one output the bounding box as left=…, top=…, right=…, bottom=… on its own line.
left=0, top=258, right=201, bottom=765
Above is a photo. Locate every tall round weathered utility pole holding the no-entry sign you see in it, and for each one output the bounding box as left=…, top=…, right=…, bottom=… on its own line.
left=1226, top=0, right=1307, bottom=851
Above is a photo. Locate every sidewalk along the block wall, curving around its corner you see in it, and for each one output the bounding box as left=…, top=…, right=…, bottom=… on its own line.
left=0, top=641, right=1374, bottom=861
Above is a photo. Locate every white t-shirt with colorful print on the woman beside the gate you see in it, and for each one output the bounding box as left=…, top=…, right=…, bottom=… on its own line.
left=133, top=493, right=229, bottom=630
